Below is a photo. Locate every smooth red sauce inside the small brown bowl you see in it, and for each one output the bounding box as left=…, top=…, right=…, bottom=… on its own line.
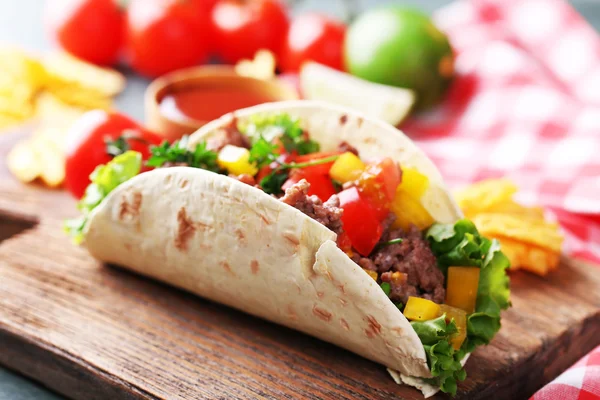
left=159, top=86, right=277, bottom=122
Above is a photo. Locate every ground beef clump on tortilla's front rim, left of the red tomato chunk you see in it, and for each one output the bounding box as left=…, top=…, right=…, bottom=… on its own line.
left=279, top=179, right=344, bottom=235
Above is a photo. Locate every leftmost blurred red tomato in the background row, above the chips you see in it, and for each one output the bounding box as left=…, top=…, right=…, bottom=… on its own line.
left=44, top=0, right=125, bottom=65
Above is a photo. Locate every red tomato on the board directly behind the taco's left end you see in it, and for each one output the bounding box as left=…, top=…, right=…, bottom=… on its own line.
left=65, top=110, right=162, bottom=198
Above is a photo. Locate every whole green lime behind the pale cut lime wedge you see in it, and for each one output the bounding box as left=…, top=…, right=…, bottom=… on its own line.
left=344, top=6, right=454, bottom=109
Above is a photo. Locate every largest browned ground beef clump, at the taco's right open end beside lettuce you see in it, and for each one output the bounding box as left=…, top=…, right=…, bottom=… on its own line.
left=352, top=214, right=446, bottom=304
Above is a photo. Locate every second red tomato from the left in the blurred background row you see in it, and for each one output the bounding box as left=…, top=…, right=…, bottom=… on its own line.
left=126, top=0, right=211, bottom=77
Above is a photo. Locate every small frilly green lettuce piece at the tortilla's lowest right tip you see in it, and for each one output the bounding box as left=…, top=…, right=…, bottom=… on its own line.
left=411, top=314, right=467, bottom=396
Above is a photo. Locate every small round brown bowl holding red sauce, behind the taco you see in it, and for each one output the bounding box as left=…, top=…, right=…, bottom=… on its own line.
left=144, top=65, right=298, bottom=141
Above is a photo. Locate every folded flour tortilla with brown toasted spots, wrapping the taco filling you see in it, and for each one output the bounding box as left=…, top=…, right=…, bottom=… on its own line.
left=85, top=101, right=461, bottom=395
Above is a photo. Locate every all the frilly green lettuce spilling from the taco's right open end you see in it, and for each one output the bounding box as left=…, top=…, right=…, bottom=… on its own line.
left=411, top=219, right=510, bottom=395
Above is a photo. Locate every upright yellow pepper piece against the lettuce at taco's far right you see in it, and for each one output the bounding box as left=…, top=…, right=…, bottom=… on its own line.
left=446, top=267, right=480, bottom=314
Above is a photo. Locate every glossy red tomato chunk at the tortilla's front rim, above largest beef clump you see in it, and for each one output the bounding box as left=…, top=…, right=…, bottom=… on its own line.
left=338, top=187, right=382, bottom=257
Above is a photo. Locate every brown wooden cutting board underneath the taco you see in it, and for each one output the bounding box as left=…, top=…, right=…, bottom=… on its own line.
left=0, top=130, right=600, bottom=400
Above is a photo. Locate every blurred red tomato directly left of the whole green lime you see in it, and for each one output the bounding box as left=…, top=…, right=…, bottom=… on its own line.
left=279, top=13, right=346, bottom=72
